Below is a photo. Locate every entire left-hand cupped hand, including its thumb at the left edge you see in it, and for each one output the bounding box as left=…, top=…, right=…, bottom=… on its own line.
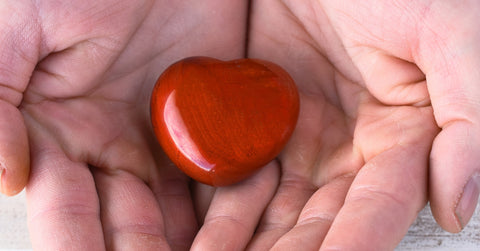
left=0, top=0, right=247, bottom=250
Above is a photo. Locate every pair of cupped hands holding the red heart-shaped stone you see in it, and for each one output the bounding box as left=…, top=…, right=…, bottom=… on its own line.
left=0, top=0, right=480, bottom=250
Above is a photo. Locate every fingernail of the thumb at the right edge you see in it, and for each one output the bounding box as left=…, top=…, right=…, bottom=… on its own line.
left=455, top=174, right=480, bottom=229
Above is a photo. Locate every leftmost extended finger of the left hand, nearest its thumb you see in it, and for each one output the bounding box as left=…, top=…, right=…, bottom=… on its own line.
left=27, top=143, right=104, bottom=250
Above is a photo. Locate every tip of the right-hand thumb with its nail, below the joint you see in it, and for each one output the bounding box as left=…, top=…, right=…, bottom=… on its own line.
left=429, top=121, right=480, bottom=233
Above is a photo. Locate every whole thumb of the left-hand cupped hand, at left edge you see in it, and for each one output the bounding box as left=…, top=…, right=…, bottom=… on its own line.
left=0, top=1, right=40, bottom=195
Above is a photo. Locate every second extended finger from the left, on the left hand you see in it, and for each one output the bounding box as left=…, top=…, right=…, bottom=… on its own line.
left=94, top=170, right=170, bottom=250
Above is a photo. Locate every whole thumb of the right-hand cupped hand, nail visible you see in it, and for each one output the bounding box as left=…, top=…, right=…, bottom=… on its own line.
left=418, top=1, right=480, bottom=232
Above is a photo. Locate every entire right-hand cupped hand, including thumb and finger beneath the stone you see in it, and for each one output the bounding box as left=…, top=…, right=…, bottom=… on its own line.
left=194, top=0, right=480, bottom=250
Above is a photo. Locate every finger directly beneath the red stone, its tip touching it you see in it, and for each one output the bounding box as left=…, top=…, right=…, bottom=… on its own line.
left=192, top=161, right=279, bottom=250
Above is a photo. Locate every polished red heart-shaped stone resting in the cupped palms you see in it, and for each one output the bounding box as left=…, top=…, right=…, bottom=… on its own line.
left=151, top=57, right=299, bottom=186
